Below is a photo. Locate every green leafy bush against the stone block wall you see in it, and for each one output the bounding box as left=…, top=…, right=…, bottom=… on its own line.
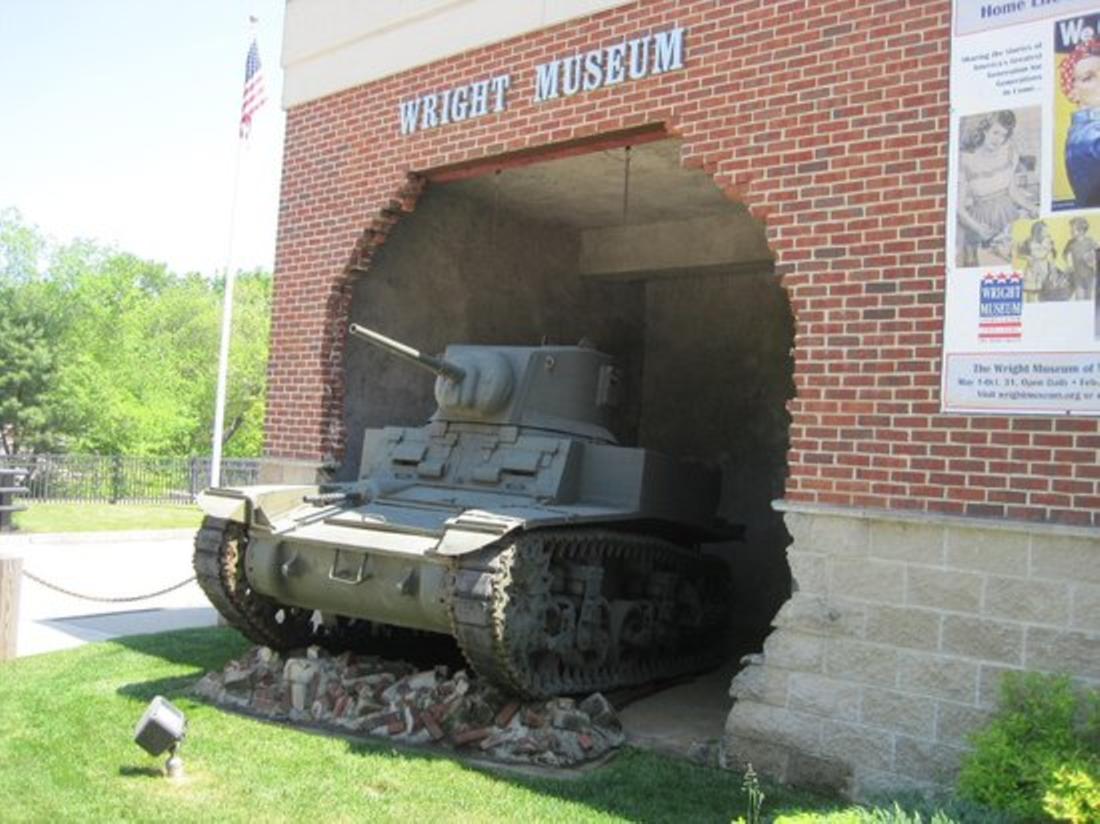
left=958, top=672, right=1100, bottom=822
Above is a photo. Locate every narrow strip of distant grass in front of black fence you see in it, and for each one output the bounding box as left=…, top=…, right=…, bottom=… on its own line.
left=14, top=501, right=202, bottom=532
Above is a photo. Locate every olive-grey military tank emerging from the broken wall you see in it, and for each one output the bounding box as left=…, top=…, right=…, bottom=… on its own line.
left=195, top=325, right=739, bottom=697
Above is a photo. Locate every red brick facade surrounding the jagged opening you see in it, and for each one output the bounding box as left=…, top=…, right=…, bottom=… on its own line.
left=267, top=0, right=1100, bottom=526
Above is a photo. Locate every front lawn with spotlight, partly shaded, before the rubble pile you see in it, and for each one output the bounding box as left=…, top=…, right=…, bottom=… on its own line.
left=0, top=629, right=1003, bottom=823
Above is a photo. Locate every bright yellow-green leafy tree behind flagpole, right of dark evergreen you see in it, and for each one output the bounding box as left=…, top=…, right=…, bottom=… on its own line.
left=50, top=255, right=271, bottom=454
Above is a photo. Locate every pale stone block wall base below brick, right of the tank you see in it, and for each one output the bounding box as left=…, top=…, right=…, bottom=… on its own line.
left=725, top=502, right=1100, bottom=798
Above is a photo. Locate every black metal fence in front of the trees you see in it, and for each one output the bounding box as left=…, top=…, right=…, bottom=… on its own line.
left=0, top=454, right=260, bottom=504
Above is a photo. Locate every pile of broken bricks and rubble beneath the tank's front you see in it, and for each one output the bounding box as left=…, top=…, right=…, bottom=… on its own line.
left=195, top=647, right=624, bottom=767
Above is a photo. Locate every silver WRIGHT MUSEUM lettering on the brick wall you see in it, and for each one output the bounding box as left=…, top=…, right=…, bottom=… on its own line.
left=397, top=26, right=686, bottom=134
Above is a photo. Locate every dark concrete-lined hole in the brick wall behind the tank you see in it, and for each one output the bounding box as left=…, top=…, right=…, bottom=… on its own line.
left=340, top=140, right=793, bottom=734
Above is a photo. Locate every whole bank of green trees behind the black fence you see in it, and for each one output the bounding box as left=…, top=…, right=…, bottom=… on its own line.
left=0, top=210, right=271, bottom=455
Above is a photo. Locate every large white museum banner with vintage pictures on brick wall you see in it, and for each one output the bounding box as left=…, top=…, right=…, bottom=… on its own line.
left=942, top=0, right=1100, bottom=415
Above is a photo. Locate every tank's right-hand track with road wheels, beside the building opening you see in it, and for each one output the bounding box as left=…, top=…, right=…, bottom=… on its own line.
left=450, top=529, right=732, bottom=699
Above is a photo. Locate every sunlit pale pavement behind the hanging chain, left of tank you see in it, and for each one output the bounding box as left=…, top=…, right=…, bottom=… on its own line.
left=0, top=529, right=217, bottom=657
